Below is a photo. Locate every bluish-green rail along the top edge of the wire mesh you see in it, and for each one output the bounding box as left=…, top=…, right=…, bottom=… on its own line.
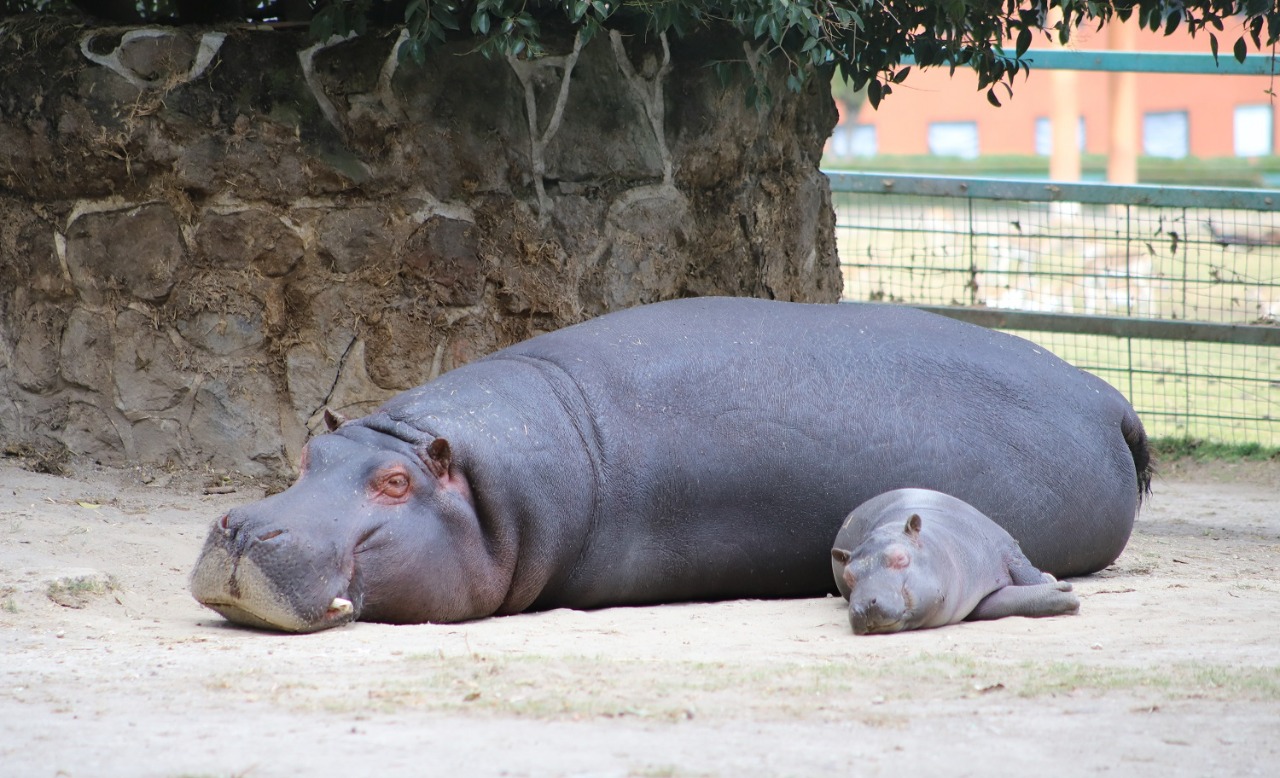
left=826, top=170, right=1280, bottom=211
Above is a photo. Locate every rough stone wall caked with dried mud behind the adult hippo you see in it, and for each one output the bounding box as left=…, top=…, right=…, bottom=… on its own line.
left=0, top=19, right=838, bottom=476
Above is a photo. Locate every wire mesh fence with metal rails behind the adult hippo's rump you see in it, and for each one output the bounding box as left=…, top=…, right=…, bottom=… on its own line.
left=829, top=173, right=1280, bottom=447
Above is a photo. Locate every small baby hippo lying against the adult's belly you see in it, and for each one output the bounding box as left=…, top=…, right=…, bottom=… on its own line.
left=831, top=489, right=1080, bottom=635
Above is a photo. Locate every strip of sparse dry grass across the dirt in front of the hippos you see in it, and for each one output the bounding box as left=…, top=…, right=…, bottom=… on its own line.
left=292, top=653, right=1280, bottom=727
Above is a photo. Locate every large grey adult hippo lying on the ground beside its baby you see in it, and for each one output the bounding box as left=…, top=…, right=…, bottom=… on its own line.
left=192, top=298, right=1149, bottom=632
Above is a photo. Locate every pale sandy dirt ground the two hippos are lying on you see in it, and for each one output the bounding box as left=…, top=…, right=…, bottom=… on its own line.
left=0, top=461, right=1280, bottom=777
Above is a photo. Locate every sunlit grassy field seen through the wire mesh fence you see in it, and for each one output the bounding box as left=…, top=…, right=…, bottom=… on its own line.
left=833, top=192, right=1280, bottom=456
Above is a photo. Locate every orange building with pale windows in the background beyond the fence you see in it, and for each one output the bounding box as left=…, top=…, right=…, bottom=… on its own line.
left=829, top=22, right=1280, bottom=157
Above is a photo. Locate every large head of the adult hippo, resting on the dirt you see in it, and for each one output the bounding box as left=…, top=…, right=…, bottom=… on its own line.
left=191, top=422, right=506, bottom=632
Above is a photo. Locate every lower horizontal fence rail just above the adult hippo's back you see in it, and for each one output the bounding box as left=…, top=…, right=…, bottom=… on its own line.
left=849, top=303, right=1280, bottom=345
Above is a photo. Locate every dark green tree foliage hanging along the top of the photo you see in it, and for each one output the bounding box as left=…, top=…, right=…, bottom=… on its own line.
left=10, top=0, right=1280, bottom=105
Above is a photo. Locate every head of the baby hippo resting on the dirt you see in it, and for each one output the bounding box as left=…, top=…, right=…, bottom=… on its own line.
left=831, top=513, right=942, bottom=635
